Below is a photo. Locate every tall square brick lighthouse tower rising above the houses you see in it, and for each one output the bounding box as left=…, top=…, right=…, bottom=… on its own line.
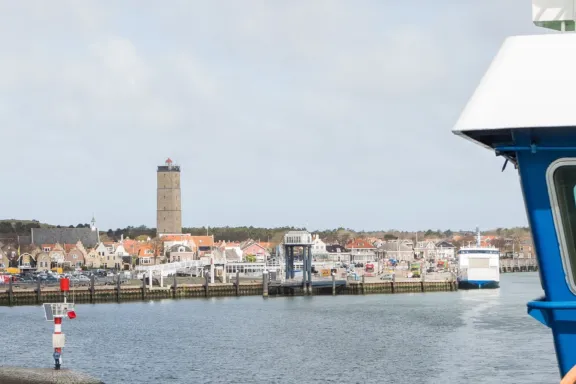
left=156, top=159, right=182, bottom=236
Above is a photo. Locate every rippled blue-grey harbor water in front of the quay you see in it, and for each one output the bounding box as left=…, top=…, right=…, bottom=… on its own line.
left=0, top=273, right=559, bottom=384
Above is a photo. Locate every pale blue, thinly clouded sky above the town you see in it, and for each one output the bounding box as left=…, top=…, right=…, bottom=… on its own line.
left=0, top=0, right=545, bottom=230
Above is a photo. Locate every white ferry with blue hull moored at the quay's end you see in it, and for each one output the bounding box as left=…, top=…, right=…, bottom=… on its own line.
left=458, top=231, right=500, bottom=289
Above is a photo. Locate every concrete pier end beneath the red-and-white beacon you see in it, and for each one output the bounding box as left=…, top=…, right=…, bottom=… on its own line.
left=0, top=367, right=104, bottom=384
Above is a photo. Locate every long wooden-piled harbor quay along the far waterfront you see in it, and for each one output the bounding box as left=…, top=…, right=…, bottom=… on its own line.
left=0, top=275, right=457, bottom=306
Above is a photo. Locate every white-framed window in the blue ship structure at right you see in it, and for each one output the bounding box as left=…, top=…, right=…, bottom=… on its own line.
left=547, top=159, right=576, bottom=292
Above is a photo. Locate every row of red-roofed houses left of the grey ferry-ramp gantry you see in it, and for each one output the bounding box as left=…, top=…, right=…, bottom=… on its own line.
left=0, top=228, right=270, bottom=273
